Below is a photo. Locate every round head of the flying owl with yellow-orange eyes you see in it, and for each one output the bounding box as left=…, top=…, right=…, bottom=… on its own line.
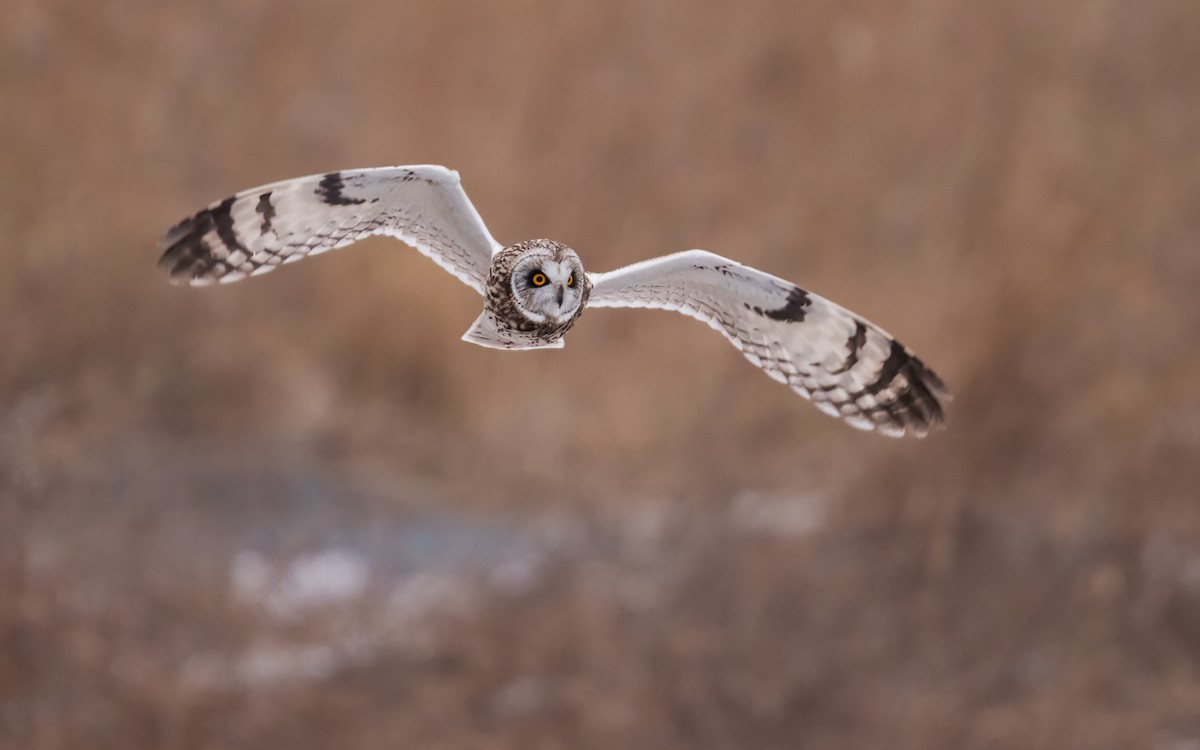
left=509, top=240, right=592, bottom=325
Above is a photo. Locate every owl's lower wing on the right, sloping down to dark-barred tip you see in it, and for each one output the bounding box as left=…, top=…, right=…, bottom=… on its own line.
left=588, top=250, right=948, bottom=437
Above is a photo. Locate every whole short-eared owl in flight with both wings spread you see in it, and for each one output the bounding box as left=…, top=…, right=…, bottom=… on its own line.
left=160, top=166, right=948, bottom=437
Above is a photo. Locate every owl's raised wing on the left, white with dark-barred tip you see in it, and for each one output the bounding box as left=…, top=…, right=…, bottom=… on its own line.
left=158, top=164, right=500, bottom=294
